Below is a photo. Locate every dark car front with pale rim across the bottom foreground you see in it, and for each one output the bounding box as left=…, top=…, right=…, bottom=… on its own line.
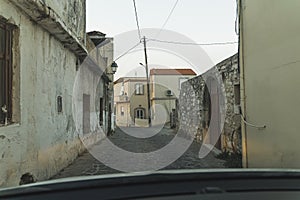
left=0, top=170, right=300, bottom=200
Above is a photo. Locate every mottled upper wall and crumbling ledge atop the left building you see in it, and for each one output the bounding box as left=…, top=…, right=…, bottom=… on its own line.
left=9, top=0, right=87, bottom=58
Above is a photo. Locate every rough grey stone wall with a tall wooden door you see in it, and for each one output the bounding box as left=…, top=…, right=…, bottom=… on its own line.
left=179, top=54, right=241, bottom=152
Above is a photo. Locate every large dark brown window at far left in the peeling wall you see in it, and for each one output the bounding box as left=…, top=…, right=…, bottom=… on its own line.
left=0, top=19, right=13, bottom=124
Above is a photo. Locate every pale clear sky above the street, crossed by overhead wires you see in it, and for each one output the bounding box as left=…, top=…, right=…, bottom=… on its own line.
left=87, top=0, right=238, bottom=78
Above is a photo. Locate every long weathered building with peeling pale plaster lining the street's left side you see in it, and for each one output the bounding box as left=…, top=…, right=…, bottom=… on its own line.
left=0, top=0, right=115, bottom=187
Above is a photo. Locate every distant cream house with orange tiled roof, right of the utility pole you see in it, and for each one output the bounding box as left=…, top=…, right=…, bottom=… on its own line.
left=150, top=69, right=196, bottom=125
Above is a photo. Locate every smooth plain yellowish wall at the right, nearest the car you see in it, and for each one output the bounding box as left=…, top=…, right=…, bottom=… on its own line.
left=240, top=0, right=300, bottom=168
